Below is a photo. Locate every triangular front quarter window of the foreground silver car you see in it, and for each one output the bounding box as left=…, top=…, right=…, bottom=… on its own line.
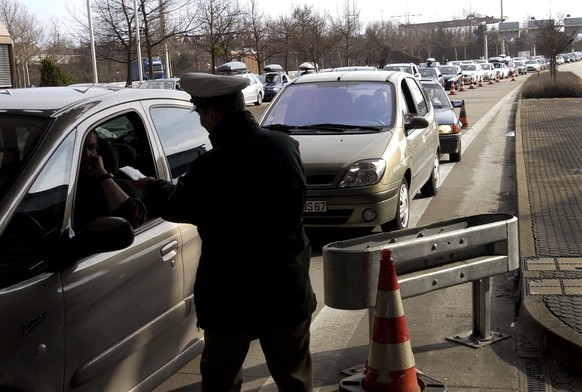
left=0, top=135, right=74, bottom=288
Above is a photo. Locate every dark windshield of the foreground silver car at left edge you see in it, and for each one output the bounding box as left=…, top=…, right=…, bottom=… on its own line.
left=0, top=114, right=50, bottom=198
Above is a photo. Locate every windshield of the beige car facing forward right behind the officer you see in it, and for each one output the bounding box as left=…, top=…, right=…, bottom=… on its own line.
left=261, top=82, right=396, bottom=133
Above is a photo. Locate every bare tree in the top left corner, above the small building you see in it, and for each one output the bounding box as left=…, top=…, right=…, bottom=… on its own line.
left=0, top=0, right=43, bottom=87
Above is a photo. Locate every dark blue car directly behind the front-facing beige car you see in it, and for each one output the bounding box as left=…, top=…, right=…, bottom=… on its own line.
left=420, top=80, right=463, bottom=162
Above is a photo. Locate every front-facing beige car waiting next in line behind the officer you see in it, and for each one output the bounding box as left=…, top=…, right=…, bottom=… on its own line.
left=260, top=71, right=440, bottom=231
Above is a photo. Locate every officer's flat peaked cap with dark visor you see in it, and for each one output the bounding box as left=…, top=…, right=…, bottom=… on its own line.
left=180, top=72, right=249, bottom=105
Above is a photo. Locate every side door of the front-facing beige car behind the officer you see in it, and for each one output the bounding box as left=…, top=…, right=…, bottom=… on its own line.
left=401, top=77, right=438, bottom=196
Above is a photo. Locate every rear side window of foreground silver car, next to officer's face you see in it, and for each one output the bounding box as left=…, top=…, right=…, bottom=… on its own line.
left=151, top=107, right=212, bottom=182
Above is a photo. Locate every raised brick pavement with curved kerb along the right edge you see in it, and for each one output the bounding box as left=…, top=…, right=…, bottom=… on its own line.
left=515, top=98, right=582, bottom=373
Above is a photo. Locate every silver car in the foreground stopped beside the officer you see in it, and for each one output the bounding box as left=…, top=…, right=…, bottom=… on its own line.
left=0, top=87, right=211, bottom=392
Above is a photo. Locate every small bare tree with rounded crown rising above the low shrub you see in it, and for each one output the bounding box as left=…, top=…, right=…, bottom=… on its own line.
left=536, top=19, right=576, bottom=79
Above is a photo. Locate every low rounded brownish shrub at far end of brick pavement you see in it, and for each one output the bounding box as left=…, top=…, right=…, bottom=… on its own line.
left=521, top=72, right=582, bottom=98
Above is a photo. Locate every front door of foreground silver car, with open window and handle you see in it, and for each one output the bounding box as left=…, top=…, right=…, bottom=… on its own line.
left=61, top=102, right=193, bottom=391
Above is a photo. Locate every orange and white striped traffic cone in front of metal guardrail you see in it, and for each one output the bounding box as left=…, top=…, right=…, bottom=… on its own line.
left=363, top=249, right=421, bottom=392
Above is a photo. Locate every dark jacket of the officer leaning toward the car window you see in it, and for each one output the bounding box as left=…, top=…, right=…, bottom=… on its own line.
left=147, top=111, right=316, bottom=332
